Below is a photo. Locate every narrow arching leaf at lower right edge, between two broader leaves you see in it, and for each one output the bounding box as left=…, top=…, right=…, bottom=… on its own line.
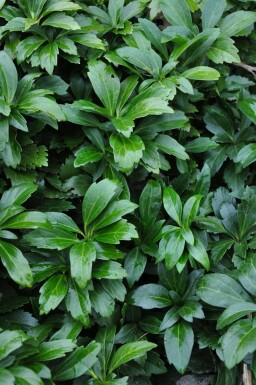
left=217, top=302, right=256, bottom=329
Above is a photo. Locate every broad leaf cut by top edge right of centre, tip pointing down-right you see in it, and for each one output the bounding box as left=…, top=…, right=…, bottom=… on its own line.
left=160, top=0, right=193, bottom=29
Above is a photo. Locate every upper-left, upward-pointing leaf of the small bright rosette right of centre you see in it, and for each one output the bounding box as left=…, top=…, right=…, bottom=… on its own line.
left=163, top=187, right=182, bottom=225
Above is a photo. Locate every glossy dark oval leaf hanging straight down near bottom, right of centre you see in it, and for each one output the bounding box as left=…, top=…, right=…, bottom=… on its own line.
left=164, top=321, right=194, bottom=374
